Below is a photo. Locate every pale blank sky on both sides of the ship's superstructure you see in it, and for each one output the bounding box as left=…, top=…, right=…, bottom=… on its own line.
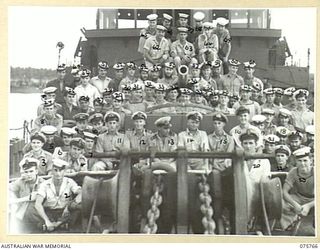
left=8, top=6, right=316, bottom=72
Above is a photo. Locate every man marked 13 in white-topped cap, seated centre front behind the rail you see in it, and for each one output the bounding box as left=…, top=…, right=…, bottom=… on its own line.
left=150, top=116, right=178, bottom=169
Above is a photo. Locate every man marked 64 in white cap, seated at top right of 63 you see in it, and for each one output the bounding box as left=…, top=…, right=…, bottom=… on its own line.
left=197, top=22, right=219, bottom=63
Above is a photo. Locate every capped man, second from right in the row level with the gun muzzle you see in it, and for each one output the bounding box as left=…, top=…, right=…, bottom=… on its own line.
left=222, top=58, right=244, bottom=95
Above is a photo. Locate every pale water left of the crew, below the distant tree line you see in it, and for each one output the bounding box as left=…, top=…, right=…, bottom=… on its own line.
left=9, top=93, right=41, bottom=139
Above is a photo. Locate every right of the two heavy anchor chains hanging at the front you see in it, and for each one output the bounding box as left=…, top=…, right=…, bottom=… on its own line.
left=198, top=174, right=216, bottom=234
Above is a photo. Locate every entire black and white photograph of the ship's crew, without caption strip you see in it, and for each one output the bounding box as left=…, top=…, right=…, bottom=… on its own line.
left=7, top=5, right=317, bottom=236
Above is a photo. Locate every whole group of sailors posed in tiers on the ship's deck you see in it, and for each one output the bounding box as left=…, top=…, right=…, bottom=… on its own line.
left=10, top=10, right=314, bottom=235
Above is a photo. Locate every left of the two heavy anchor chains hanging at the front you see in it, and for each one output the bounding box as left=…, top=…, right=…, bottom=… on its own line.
left=143, top=175, right=163, bottom=234
